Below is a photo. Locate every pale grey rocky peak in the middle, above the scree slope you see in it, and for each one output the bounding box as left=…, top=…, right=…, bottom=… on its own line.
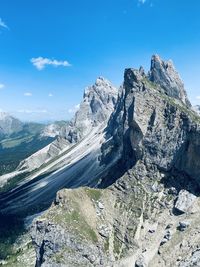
left=66, top=77, right=118, bottom=143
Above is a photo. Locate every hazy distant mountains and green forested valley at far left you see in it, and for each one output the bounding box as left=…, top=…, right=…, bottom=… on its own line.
left=0, top=112, right=67, bottom=175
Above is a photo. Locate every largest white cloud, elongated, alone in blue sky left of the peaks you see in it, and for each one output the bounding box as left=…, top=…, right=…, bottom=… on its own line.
left=31, top=57, right=71, bottom=70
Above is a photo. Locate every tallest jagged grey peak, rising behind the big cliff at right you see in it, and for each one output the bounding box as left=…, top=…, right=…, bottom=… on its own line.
left=149, top=55, right=191, bottom=106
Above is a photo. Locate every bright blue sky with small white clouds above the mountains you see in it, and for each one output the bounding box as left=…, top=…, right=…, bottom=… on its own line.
left=0, top=0, right=200, bottom=121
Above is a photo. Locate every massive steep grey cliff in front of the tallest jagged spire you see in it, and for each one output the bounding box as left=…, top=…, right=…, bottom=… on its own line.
left=102, top=57, right=200, bottom=188
